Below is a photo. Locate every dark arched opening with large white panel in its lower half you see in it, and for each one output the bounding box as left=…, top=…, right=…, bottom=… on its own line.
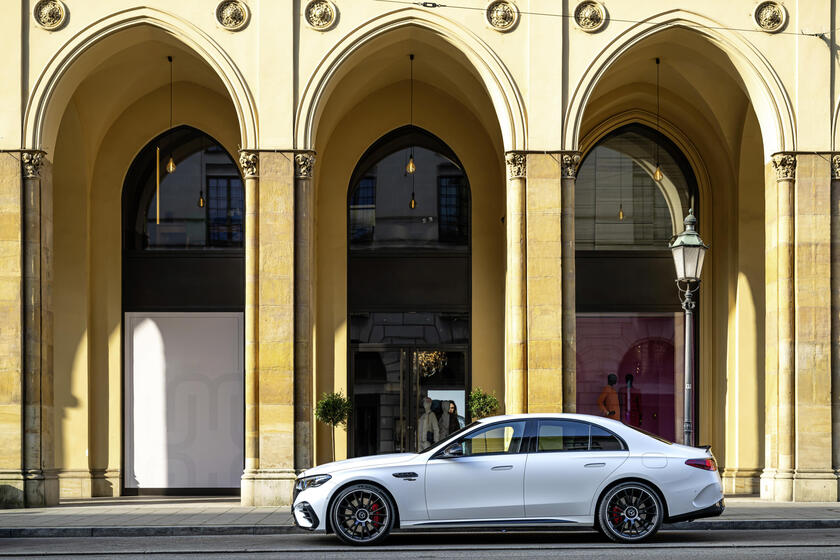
left=122, top=126, right=244, bottom=494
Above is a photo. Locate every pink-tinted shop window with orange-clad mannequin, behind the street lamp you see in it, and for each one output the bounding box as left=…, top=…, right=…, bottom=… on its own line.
left=577, top=313, right=684, bottom=441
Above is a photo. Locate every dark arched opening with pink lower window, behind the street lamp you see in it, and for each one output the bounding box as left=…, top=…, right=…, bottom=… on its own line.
left=575, top=124, right=700, bottom=440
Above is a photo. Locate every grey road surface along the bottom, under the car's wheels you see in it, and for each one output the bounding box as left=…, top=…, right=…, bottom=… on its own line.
left=0, top=529, right=840, bottom=560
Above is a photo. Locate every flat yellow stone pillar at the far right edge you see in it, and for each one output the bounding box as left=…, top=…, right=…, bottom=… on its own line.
left=791, top=153, right=837, bottom=502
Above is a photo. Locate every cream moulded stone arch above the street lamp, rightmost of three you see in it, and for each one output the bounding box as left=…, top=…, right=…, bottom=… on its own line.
left=563, top=9, right=796, bottom=159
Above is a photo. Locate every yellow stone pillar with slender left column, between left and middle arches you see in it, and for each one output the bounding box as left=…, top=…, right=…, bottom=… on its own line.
left=240, top=151, right=295, bottom=506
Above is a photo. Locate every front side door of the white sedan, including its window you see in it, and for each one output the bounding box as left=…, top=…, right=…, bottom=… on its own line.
left=426, top=420, right=526, bottom=521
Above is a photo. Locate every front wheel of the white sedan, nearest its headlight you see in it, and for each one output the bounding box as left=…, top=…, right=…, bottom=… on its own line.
left=329, top=484, right=397, bottom=545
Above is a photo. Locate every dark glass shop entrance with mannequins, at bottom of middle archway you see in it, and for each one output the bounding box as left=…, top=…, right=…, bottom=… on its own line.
left=349, top=344, right=467, bottom=457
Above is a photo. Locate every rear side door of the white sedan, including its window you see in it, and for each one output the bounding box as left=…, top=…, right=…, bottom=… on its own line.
left=524, top=419, right=629, bottom=518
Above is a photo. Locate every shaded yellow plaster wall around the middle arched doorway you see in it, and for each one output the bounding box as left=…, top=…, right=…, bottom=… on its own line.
left=315, top=81, right=505, bottom=463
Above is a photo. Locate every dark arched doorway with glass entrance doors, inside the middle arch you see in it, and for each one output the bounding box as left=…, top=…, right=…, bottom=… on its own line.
left=347, top=126, right=471, bottom=456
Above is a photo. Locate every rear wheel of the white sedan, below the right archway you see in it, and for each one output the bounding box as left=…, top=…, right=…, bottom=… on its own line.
left=595, top=482, right=665, bottom=543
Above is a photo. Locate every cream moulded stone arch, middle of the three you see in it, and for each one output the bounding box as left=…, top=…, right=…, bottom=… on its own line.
left=295, top=7, right=527, bottom=151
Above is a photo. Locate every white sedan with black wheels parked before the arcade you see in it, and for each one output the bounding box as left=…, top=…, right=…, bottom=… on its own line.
left=292, top=414, right=724, bottom=545
